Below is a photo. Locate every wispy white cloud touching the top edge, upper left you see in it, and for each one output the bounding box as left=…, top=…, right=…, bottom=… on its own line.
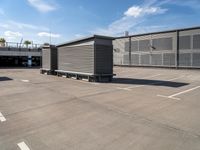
left=28, top=0, right=56, bottom=12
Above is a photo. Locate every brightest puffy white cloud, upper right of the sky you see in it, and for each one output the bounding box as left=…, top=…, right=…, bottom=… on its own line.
left=124, top=6, right=167, bottom=18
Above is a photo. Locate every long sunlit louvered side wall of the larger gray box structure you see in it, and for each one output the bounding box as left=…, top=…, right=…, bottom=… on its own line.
left=58, top=45, right=94, bottom=74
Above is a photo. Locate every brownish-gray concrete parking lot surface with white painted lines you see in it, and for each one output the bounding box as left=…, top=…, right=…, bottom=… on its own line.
left=0, top=67, right=200, bottom=150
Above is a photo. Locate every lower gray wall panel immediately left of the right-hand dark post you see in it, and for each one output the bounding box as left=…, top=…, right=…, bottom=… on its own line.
left=163, top=53, right=176, bottom=66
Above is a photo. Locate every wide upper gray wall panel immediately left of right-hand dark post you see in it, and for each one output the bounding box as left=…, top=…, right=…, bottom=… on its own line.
left=152, top=38, right=173, bottom=51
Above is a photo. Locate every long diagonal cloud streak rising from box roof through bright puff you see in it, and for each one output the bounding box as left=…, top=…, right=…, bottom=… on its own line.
left=91, top=0, right=168, bottom=36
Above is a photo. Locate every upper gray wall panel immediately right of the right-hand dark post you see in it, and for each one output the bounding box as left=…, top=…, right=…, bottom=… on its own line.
left=179, top=36, right=191, bottom=50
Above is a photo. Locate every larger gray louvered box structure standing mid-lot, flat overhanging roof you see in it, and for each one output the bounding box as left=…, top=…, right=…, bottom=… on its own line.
left=56, top=35, right=114, bottom=81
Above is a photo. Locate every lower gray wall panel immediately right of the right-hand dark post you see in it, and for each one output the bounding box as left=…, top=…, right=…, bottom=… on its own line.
left=179, top=53, right=192, bottom=67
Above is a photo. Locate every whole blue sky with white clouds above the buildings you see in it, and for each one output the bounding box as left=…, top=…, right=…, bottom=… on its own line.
left=0, top=0, right=200, bottom=44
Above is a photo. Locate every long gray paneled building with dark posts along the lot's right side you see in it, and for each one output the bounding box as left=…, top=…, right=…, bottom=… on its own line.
left=113, top=27, right=200, bottom=68
